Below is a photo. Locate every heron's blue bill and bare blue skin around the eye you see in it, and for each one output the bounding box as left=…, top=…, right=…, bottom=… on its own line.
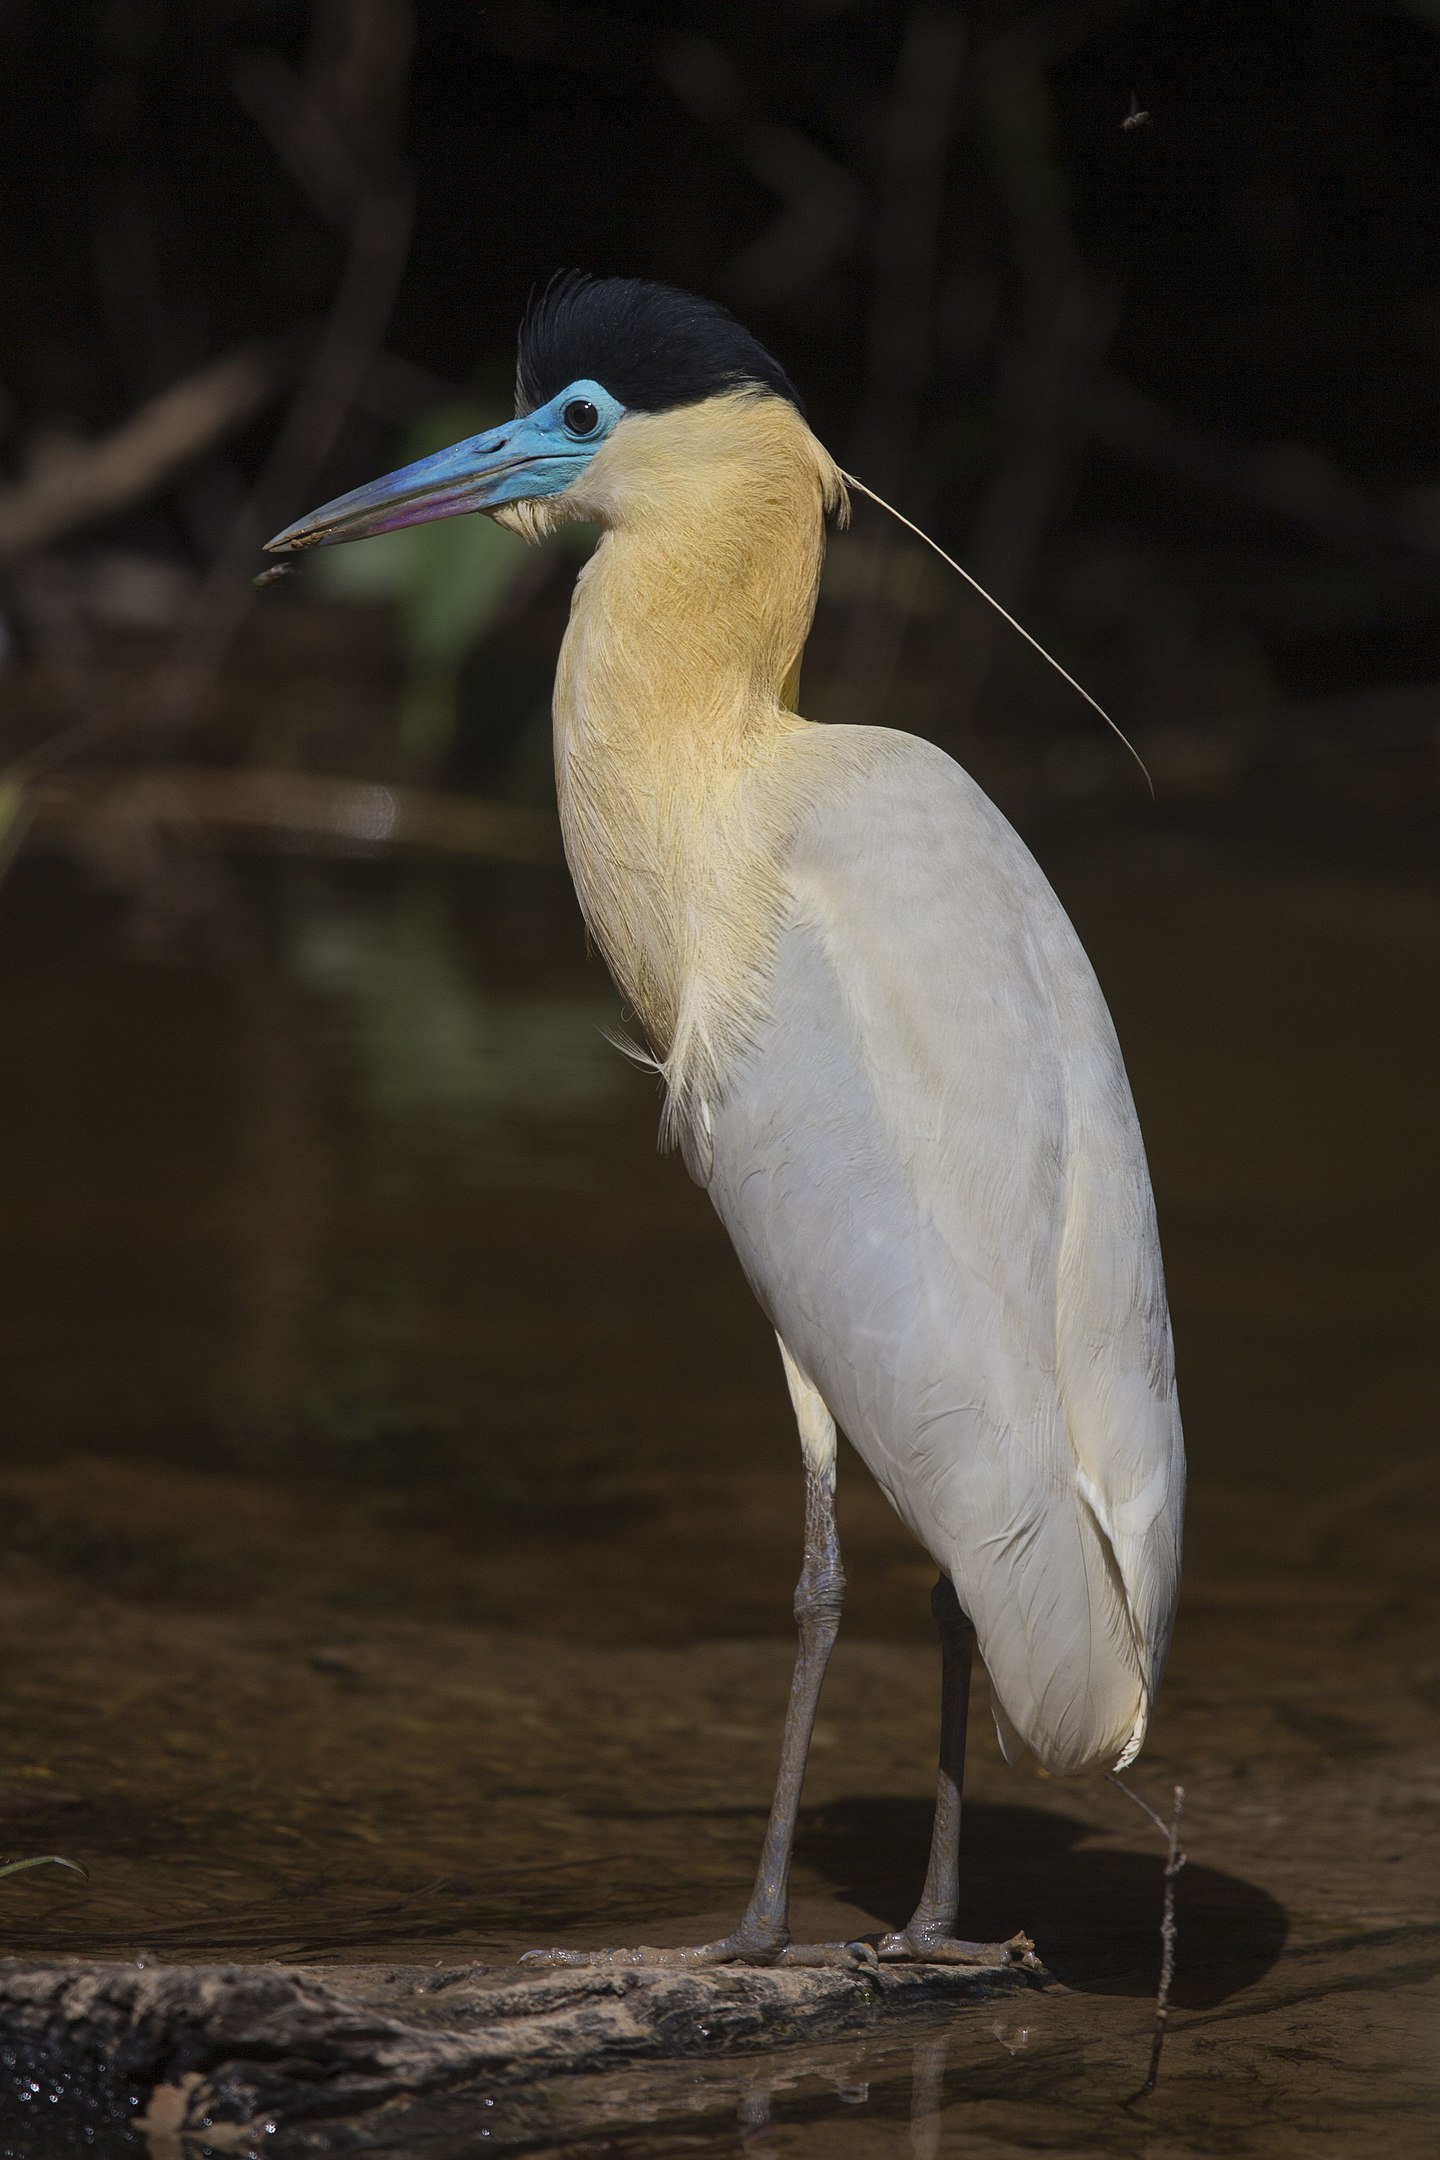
left=266, top=380, right=624, bottom=555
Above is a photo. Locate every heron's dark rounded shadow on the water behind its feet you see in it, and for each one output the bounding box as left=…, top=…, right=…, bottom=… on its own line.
left=797, top=1795, right=1289, bottom=2009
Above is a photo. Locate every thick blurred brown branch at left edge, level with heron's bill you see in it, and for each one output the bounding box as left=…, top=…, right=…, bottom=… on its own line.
left=0, top=346, right=279, bottom=564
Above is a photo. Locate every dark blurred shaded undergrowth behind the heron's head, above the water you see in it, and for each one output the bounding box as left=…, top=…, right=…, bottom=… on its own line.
left=0, top=0, right=1440, bottom=821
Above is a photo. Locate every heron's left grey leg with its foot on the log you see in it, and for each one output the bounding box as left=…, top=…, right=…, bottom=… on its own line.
left=520, top=1344, right=874, bottom=1966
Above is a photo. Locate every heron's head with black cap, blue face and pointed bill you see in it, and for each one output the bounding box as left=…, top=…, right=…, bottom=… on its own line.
left=268, top=274, right=840, bottom=555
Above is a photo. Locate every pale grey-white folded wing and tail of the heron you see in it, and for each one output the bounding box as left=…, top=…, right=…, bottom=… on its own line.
left=704, top=728, right=1185, bottom=1771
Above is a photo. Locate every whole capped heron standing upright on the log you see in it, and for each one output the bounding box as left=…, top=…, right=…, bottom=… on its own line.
left=270, top=276, right=1185, bottom=1963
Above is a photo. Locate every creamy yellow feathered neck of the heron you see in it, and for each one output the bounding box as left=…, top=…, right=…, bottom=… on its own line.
left=555, top=395, right=842, bottom=1093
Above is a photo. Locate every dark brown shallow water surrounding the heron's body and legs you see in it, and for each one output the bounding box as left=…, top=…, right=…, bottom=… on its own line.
left=0, top=816, right=1440, bottom=2160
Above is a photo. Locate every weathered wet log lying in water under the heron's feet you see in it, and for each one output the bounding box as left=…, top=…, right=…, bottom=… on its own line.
left=0, top=1959, right=1045, bottom=2160
